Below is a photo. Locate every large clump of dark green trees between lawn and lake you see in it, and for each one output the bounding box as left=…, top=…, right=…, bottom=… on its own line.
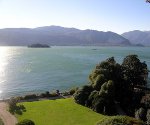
left=74, top=55, right=148, bottom=115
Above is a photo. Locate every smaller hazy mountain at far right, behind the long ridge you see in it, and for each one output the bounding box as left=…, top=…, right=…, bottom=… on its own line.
left=122, top=30, right=150, bottom=46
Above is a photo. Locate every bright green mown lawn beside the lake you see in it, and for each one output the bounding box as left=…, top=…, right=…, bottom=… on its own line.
left=17, top=98, right=105, bottom=125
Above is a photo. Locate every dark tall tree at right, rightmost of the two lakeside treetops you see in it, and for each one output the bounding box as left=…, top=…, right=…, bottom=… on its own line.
left=122, top=55, right=148, bottom=91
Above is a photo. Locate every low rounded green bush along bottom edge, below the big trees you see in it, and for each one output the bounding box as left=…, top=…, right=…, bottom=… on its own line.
left=97, top=116, right=145, bottom=125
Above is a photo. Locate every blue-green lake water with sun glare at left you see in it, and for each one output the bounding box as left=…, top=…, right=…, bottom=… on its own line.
left=0, top=47, right=150, bottom=99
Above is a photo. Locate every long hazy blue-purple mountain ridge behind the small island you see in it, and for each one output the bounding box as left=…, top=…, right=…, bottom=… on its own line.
left=0, top=26, right=131, bottom=46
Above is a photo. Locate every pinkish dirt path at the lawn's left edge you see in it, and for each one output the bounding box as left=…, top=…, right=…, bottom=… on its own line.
left=0, top=102, right=17, bottom=125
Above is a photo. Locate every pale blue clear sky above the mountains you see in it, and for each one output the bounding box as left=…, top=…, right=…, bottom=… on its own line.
left=0, top=0, right=150, bottom=34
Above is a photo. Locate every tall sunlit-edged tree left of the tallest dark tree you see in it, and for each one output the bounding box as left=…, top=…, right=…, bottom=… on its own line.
left=89, top=57, right=125, bottom=100
